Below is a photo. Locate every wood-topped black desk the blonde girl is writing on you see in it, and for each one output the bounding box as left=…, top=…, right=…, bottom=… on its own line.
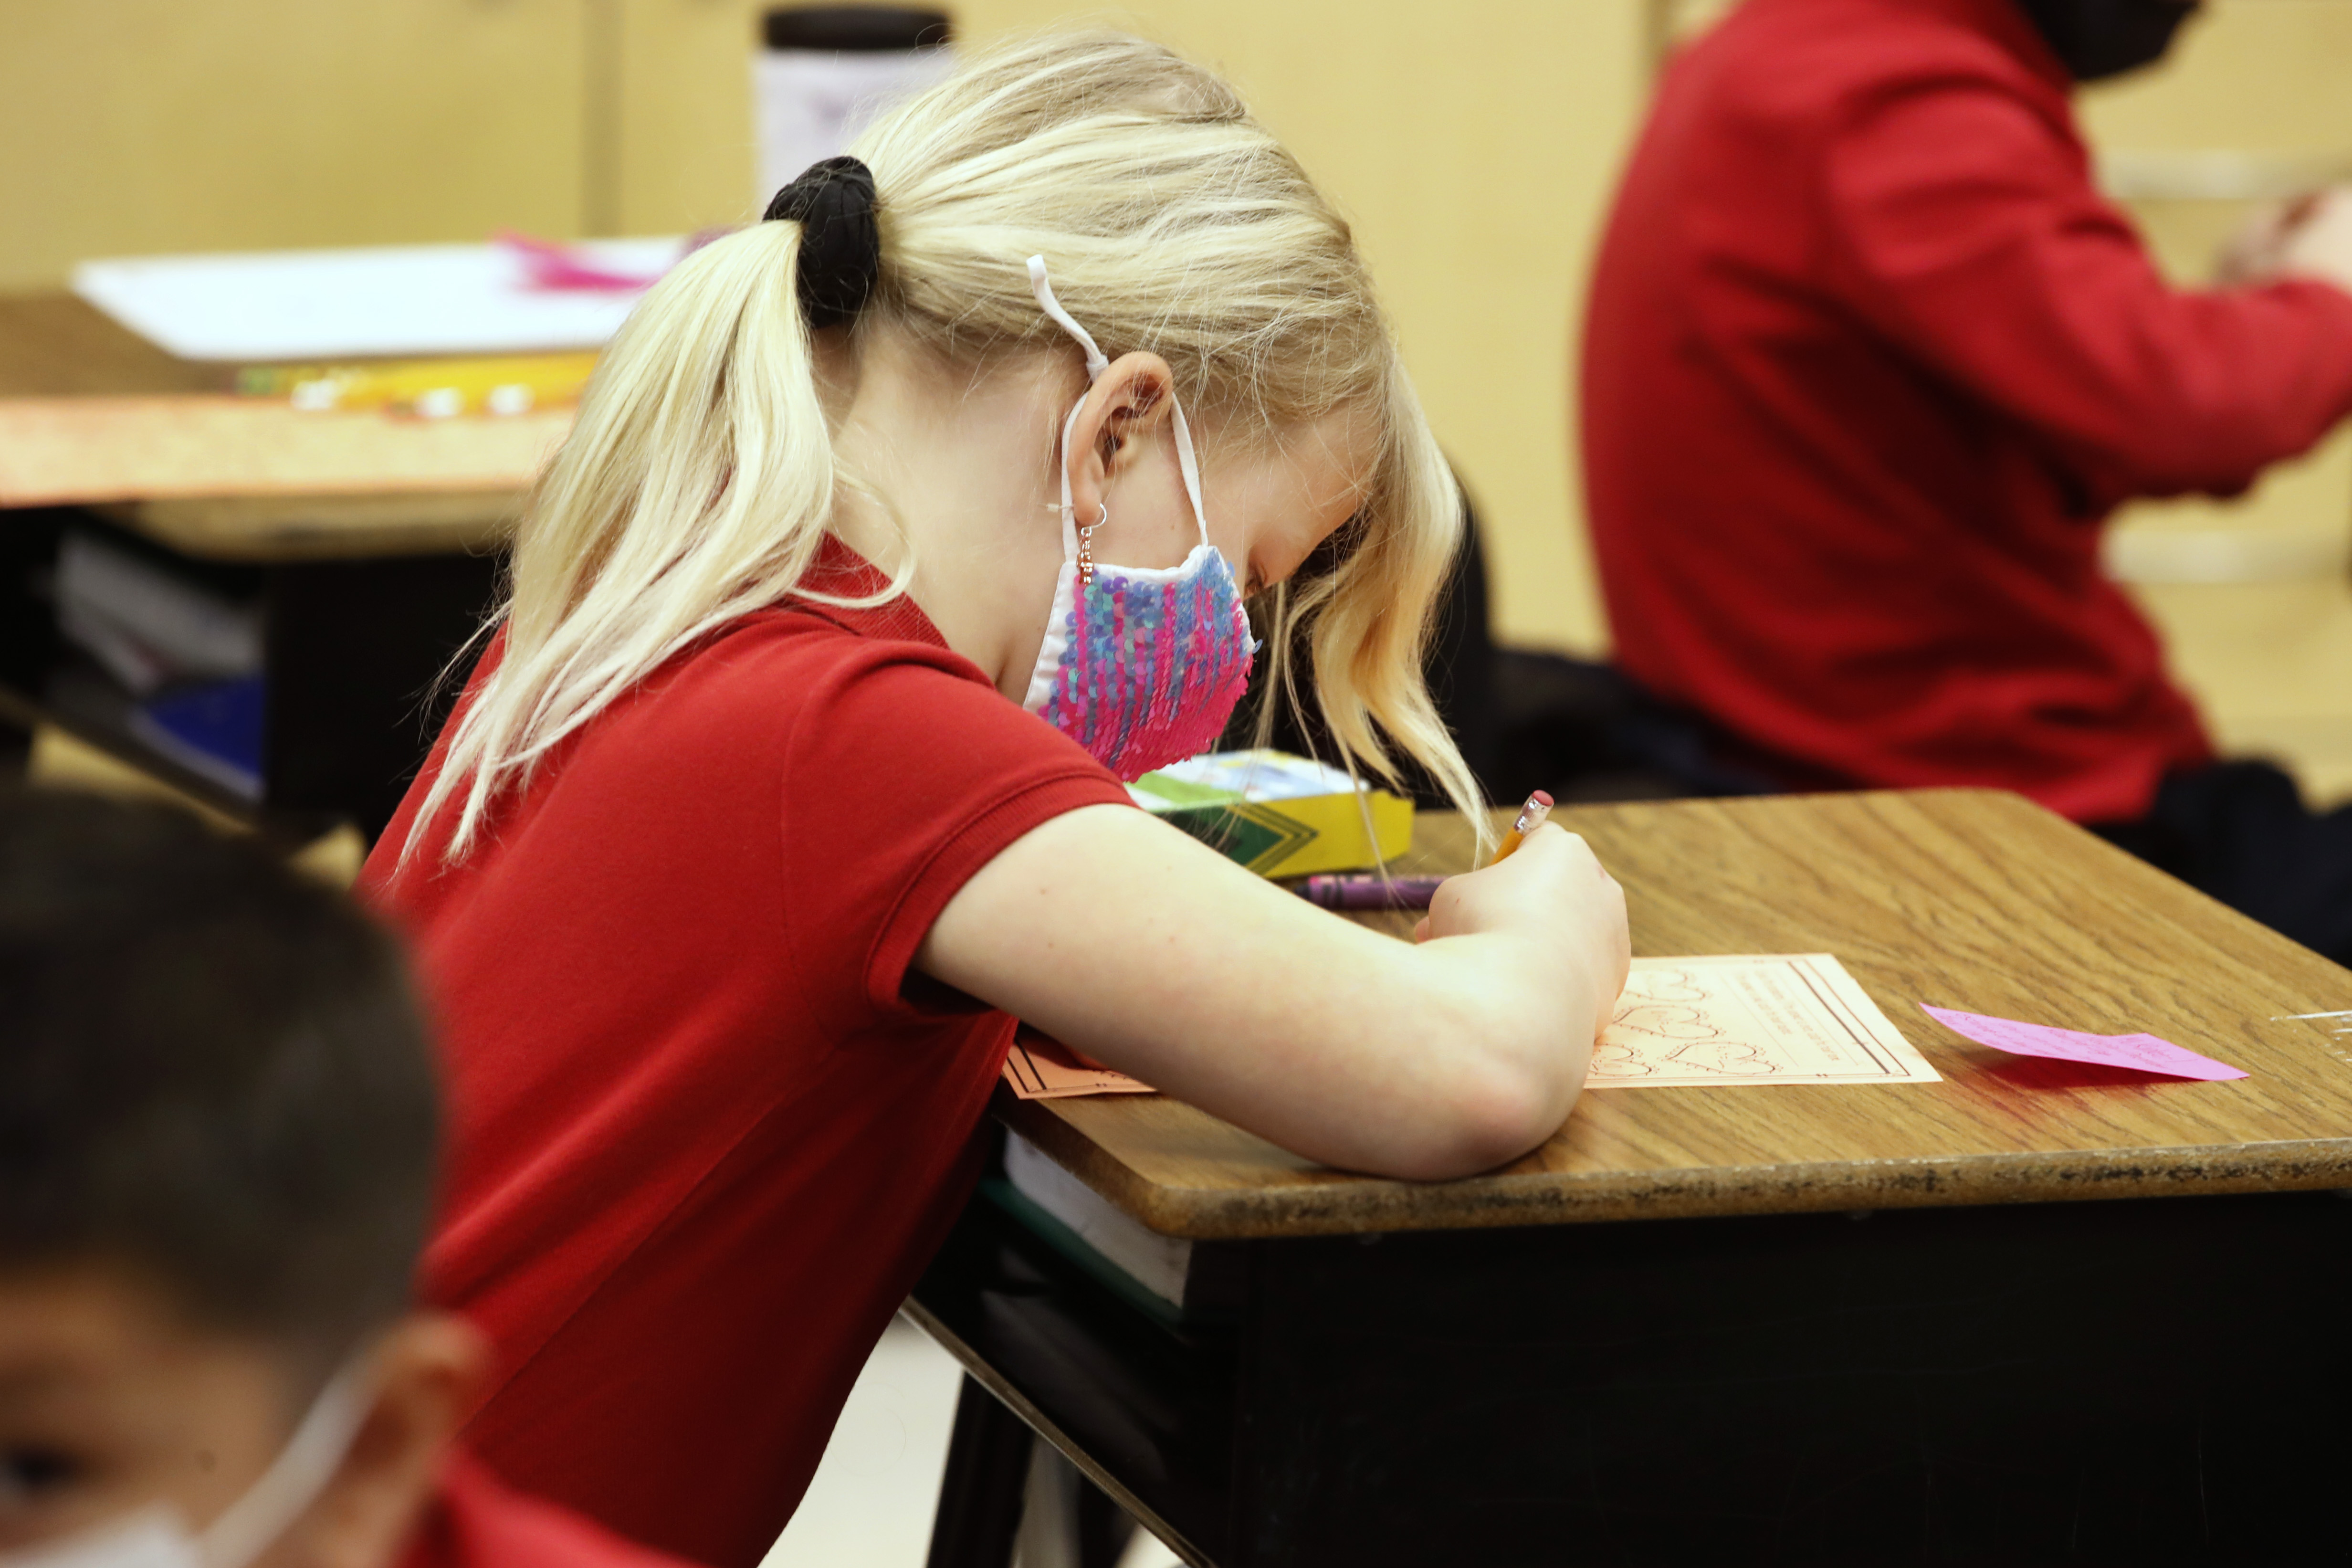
left=915, top=792, right=2352, bottom=1568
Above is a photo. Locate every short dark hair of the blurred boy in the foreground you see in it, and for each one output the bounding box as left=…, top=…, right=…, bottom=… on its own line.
left=0, top=790, right=438, bottom=1359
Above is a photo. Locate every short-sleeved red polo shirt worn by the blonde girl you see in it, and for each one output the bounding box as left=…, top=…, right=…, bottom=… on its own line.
left=360, top=552, right=1129, bottom=1568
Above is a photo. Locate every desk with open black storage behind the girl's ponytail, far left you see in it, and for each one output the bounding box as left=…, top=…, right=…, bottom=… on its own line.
left=0, top=296, right=572, bottom=839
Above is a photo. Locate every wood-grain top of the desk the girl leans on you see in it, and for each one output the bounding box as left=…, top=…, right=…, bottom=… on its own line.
left=1016, top=790, right=2352, bottom=1239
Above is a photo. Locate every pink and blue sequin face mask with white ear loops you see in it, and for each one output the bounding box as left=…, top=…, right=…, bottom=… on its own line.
left=1021, top=256, right=1258, bottom=778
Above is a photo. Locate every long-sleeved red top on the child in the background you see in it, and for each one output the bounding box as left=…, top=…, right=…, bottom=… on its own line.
left=1583, top=0, right=2352, bottom=821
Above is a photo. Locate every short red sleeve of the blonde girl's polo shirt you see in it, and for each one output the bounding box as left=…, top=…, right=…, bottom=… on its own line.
left=781, top=644, right=1131, bottom=1032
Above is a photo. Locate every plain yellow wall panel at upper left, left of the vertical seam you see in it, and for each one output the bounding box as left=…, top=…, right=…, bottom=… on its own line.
left=0, top=0, right=586, bottom=278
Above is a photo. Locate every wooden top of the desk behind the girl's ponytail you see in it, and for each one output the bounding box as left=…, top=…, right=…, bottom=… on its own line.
left=0, top=296, right=572, bottom=559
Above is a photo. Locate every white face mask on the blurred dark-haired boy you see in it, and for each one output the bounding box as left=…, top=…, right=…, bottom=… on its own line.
left=0, top=1364, right=367, bottom=1568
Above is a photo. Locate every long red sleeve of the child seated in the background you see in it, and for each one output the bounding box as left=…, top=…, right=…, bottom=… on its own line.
left=1823, top=71, right=2352, bottom=501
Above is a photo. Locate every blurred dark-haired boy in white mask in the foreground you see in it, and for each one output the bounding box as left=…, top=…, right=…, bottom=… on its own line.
left=0, top=795, right=686, bottom=1568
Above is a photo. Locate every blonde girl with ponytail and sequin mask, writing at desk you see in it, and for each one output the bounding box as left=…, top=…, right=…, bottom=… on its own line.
left=365, top=35, right=1628, bottom=1568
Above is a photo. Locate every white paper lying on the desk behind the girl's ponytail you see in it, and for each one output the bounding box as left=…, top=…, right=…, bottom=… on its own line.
left=73, top=237, right=687, bottom=360
